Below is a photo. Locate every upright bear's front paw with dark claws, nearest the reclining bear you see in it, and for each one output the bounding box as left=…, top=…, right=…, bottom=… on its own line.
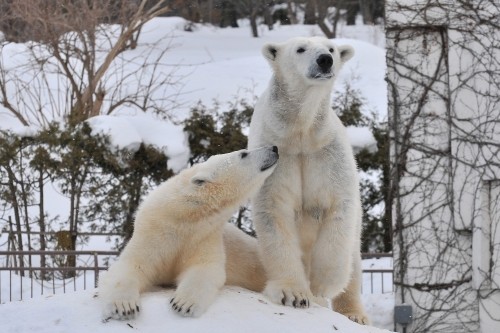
left=264, top=281, right=312, bottom=308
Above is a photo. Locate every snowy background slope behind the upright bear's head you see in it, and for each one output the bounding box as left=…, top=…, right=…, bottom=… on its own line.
left=137, top=18, right=387, bottom=117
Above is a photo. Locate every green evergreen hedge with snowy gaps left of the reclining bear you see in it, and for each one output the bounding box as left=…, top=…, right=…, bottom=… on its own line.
left=0, top=122, right=172, bottom=254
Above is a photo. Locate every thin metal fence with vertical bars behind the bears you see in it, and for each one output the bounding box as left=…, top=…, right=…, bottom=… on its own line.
left=0, top=251, right=393, bottom=304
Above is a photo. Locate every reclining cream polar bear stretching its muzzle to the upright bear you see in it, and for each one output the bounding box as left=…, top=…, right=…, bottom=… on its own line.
left=99, top=146, right=278, bottom=319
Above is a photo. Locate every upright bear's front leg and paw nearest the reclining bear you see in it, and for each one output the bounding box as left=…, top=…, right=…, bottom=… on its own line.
left=252, top=196, right=312, bottom=308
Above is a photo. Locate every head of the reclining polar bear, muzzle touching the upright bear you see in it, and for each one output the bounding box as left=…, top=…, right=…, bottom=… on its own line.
left=171, top=146, right=279, bottom=219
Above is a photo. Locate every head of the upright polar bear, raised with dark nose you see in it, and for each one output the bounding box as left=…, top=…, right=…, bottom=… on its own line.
left=262, top=37, right=354, bottom=85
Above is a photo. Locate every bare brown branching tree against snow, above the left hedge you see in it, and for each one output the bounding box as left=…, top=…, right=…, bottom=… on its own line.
left=0, top=0, right=174, bottom=125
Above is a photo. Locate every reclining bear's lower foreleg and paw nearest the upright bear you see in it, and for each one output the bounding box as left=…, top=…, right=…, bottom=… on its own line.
left=170, top=262, right=226, bottom=317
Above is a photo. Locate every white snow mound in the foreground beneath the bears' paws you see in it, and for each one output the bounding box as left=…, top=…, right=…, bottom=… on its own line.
left=0, top=287, right=389, bottom=333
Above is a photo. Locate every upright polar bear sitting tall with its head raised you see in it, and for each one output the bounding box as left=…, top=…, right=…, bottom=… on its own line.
left=248, top=37, right=368, bottom=323
